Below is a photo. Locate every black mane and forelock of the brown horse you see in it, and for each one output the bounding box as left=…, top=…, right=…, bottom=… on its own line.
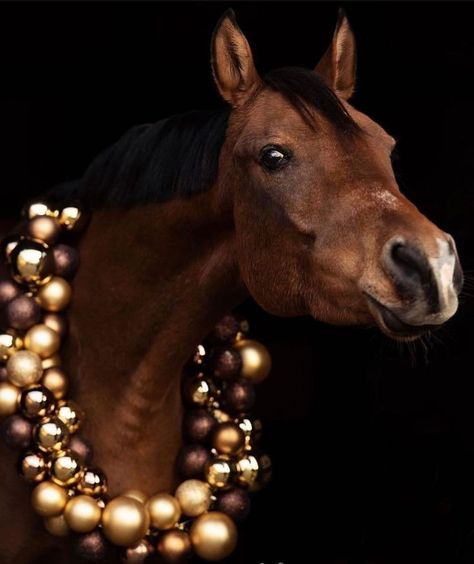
left=46, top=67, right=358, bottom=209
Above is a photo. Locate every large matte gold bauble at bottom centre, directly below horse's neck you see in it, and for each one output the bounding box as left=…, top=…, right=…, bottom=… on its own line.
left=102, top=496, right=150, bottom=546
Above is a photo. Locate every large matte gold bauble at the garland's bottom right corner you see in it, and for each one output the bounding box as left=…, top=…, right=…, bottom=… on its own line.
left=189, top=511, right=237, bottom=562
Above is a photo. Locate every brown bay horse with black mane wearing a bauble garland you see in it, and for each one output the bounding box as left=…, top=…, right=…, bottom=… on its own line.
left=0, top=8, right=462, bottom=564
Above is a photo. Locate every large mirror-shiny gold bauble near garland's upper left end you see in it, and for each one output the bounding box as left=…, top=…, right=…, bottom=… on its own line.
left=10, top=239, right=54, bottom=285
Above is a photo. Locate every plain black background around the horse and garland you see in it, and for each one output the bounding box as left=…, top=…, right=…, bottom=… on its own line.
left=0, top=2, right=474, bottom=564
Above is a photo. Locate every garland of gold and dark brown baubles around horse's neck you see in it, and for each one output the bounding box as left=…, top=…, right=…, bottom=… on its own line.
left=0, top=201, right=271, bottom=563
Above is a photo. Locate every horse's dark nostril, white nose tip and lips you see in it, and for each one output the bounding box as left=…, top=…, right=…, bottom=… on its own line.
left=363, top=235, right=463, bottom=340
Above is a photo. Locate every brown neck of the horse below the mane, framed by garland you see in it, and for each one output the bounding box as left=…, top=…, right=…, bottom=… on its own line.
left=67, top=192, right=245, bottom=493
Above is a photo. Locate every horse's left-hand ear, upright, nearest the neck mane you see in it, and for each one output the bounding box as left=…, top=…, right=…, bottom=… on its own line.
left=211, top=10, right=260, bottom=107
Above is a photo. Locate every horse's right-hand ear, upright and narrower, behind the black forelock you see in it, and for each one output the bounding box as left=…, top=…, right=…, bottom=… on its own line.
left=314, top=8, right=357, bottom=100
